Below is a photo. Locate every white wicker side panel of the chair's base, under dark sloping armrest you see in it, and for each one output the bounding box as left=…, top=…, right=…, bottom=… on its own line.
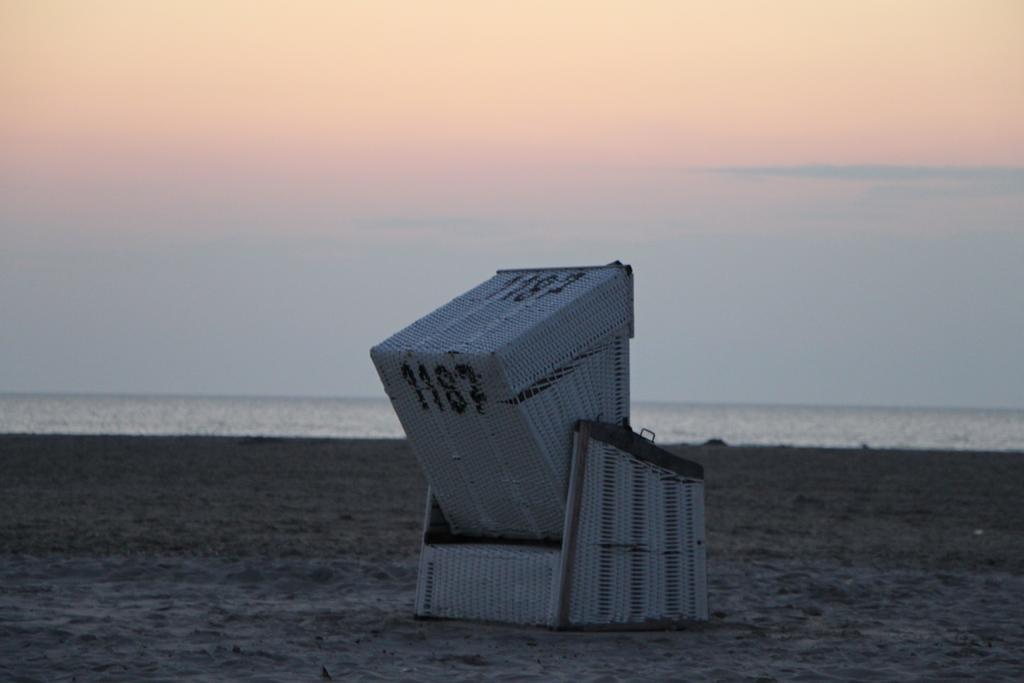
left=569, top=439, right=708, bottom=626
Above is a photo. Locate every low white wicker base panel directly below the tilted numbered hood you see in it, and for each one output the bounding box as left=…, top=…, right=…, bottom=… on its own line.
left=416, top=544, right=559, bottom=626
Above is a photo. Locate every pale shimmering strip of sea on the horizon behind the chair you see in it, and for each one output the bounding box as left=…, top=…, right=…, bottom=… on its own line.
left=0, top=394, right=1024, bottom=452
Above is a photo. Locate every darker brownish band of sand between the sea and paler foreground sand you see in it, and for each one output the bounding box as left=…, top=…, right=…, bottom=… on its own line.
left=0, top=435, right=1024, bottom=573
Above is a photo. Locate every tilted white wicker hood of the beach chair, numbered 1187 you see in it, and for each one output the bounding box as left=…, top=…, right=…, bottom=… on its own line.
left=371, top=265, right=633, bottom=539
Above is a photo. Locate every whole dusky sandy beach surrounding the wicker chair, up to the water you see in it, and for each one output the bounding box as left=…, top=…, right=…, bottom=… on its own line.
left=0, top=435, right=1024, bottom=681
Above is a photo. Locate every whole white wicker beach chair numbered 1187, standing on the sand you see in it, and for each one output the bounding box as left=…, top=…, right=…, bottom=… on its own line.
left=371, top=262, right=708, bottom=629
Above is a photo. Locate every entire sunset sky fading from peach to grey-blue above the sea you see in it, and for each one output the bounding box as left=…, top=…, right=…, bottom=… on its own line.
left=0, top=0, right=1024, bottom=408
